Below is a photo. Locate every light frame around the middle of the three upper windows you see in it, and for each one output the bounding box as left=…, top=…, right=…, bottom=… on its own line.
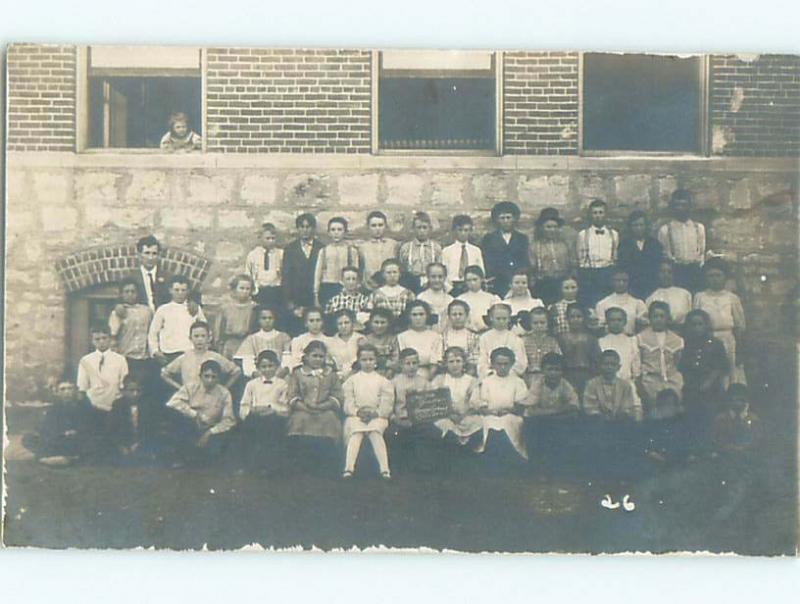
left=370, top=49, right=503, bottom=157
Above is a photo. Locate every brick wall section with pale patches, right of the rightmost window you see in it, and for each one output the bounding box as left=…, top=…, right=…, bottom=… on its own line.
left=710, top=55, right=800, bottom=157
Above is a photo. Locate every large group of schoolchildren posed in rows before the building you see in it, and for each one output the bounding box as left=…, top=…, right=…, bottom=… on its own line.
left=29, top=190, right=756, bottom=479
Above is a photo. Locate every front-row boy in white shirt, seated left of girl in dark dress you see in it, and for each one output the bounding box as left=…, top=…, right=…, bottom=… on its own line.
left=239, top=350, right=289, bottom=469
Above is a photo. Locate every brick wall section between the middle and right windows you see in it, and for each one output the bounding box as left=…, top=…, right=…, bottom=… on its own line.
left=503, top=52, right=578, bottom=155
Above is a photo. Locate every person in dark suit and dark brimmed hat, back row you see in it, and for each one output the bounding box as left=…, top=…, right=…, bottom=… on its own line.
left=481, top=201, right=530, bottom=298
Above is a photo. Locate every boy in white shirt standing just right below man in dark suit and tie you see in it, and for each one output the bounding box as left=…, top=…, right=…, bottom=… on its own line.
left=147, top=275, right=206, bottom=365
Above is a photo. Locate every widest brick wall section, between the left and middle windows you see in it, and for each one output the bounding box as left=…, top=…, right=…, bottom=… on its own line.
left=207, top=48, right=371, bottom=153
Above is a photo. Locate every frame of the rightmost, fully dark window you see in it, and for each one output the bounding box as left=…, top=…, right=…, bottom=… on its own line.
left=578, top=52, right=711, bottom=158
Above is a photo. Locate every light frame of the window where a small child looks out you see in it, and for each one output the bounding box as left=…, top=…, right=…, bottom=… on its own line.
left=75, top=46, right=208, bottom=155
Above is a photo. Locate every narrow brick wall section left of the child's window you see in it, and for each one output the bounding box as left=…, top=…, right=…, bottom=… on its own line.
left=7, top=44, right=75, bottom=151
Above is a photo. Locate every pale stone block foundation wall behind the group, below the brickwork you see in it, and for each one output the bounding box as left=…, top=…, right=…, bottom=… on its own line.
left=6, top=152, right=798, bottom=399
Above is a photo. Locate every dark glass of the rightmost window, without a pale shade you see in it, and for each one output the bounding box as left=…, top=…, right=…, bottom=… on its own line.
left=582, top=53, right=706, bottom=153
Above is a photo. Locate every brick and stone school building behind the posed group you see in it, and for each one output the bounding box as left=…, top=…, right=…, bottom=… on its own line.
left=6, top=45, right=800, bottom=398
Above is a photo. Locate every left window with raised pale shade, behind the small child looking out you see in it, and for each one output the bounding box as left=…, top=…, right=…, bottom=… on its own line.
left=88, top=46, right=202, bottom=149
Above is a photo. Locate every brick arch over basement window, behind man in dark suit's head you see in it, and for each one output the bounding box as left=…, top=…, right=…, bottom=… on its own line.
left=56, top=245, right=211, bottom=293
